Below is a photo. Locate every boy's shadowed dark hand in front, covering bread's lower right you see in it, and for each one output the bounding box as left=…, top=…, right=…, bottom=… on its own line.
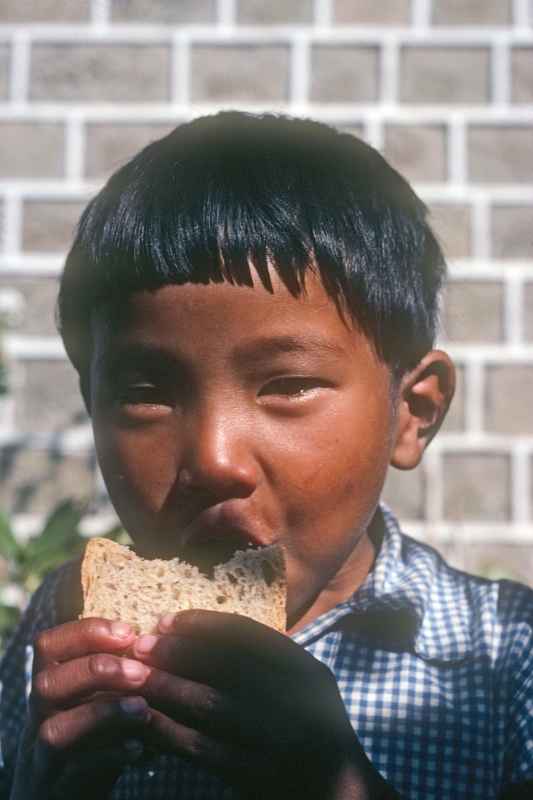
left=132, top=611, right=395, bottom=800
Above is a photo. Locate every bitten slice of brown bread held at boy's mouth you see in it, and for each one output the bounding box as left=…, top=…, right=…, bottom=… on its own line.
left=81, top=538, right=287, bottom=633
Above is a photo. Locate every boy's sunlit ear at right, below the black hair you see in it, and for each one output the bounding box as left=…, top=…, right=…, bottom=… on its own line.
left=390, top=350, right=455, bottom=469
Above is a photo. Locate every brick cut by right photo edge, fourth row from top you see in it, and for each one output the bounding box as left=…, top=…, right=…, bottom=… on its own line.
left=491, top=206, right=533, bottom=258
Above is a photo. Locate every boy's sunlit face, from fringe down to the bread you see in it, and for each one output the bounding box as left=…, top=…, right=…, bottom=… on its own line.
left=90, top=273, right=396, bottom=620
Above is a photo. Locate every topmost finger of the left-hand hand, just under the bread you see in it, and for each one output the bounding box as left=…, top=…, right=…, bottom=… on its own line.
left=34, top=617, right=135, bottom=671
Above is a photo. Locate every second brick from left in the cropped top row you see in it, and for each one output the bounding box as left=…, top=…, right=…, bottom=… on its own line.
left=111, top=0, right=216, bottom=25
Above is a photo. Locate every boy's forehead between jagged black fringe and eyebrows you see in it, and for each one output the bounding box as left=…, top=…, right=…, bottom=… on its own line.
left=93, top=271, right=377, bottom=368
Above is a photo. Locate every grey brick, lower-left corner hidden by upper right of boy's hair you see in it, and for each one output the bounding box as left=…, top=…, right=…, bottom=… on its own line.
left=384, top=125, right=448, bottom=182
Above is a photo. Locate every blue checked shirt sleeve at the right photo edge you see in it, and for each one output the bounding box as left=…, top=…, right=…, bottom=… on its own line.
left=499, top=582, right=533, bottom=786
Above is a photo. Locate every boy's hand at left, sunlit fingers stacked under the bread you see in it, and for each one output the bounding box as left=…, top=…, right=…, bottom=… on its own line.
left=11, top=618, right=150, bottom=800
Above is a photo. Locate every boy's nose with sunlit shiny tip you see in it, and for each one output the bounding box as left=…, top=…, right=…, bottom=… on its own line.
left=178, top=403, right=258, bottom=502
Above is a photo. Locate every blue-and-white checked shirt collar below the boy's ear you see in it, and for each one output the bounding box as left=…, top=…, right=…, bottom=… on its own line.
left=293, top=504, right=472, bottom=661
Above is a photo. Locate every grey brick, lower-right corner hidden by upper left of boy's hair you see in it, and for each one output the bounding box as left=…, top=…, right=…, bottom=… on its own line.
left=85, top=122, right=175, bottom=179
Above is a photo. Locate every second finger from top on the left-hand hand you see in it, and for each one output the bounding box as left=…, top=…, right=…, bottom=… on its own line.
left=31, top=653, right=151, bottom=716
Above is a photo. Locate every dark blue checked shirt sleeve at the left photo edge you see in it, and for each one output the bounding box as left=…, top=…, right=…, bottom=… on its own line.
left=0, top=571, right=61, bottom=800
